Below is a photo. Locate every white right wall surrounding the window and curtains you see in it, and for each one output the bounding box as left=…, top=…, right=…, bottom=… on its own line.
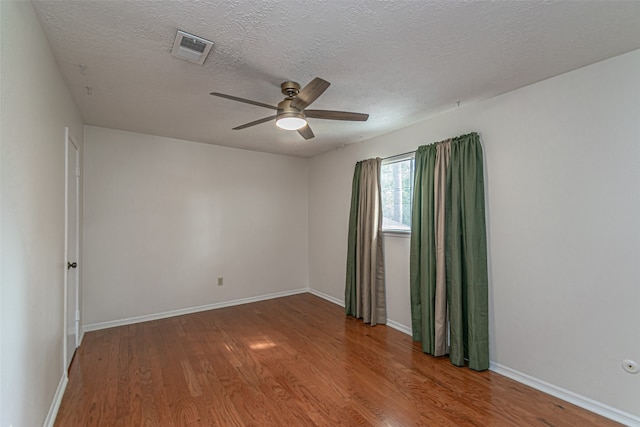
left=309, top=51, right=640, bottom=416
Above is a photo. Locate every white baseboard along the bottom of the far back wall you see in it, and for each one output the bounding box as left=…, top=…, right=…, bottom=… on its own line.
left=82, top=288, right=309, bottom=336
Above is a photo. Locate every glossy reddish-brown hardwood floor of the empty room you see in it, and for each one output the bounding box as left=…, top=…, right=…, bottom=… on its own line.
left=55, top=294, right=618, bottom=427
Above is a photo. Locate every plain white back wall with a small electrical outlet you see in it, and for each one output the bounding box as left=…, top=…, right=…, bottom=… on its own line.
left=84, top=127, right=308, bottom=325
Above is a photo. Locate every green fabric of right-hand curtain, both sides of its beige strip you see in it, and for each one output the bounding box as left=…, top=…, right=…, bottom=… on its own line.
left=410, top=133, right=489, bottom=371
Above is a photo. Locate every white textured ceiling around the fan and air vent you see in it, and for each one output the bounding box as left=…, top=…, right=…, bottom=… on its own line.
left=33, top=0, right=640, bottom=157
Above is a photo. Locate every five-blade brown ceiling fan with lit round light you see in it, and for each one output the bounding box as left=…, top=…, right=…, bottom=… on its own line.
left=210, top=77, right=369, bottom=139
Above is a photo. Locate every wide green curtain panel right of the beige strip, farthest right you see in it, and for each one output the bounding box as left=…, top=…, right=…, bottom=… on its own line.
left=445, top=133, right=489, bottom=371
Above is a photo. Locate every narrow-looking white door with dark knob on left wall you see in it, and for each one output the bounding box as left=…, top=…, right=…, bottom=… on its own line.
left=64, top=128, right=80, bottom=371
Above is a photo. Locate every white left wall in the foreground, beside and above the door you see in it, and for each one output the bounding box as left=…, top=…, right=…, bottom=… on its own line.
left=0, top=1, right=83, bottom=427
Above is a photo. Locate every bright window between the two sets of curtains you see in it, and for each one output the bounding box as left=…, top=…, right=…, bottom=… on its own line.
left=380, top=153, right=414, bottom=232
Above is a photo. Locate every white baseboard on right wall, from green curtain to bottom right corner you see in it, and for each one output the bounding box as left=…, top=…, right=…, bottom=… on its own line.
left=489, top=362, right=640, bottom=427
